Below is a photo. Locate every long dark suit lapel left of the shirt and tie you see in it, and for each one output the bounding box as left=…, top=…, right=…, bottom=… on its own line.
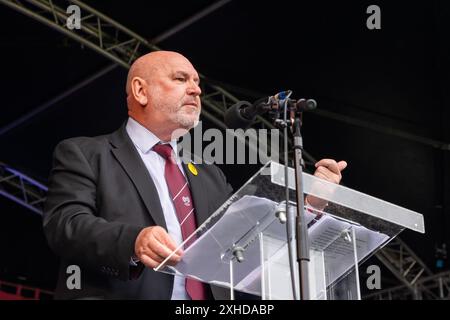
left=110, top=125, right=167, bottom=230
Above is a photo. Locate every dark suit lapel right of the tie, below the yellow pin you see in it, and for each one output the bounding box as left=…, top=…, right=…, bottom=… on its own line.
left=183, top=163, right=209, bottom=227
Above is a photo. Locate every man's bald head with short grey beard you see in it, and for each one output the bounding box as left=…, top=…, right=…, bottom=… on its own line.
left=126, top=51, right=201, bottom=141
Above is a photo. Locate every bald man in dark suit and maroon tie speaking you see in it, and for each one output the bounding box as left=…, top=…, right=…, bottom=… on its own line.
left=43, top=51, right=347, bottom=300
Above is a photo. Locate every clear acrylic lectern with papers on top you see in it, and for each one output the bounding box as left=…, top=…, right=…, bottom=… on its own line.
left=155, top=162, right=424, bottom=300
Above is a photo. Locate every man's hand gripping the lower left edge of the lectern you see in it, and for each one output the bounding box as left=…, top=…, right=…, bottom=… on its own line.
left=134, top=226, right=183, bottom=268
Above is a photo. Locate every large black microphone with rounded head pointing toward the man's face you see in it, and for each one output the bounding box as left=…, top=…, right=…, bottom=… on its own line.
left=224, top=91, right=290, bottom=129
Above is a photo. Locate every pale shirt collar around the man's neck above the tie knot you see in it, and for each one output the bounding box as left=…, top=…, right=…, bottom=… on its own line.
left=126, top=117, right=177, bottom=154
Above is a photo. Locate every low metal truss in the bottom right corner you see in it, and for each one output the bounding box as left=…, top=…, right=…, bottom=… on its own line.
left=364, top=271, right=450, bottom=300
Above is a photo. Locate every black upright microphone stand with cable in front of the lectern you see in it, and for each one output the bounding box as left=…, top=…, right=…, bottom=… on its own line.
left=275, top=93, right=310, bottom=300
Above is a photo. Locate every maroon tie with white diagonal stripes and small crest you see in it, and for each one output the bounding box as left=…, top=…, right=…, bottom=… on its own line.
left=153, top=144, right=206, bottom=300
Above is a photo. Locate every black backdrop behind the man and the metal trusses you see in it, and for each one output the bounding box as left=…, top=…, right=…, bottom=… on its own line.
left=0, top=0, right=450, bottom=289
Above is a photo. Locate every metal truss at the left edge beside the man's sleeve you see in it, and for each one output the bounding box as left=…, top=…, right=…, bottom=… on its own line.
left=0, top=163, right=48, bottom=215
